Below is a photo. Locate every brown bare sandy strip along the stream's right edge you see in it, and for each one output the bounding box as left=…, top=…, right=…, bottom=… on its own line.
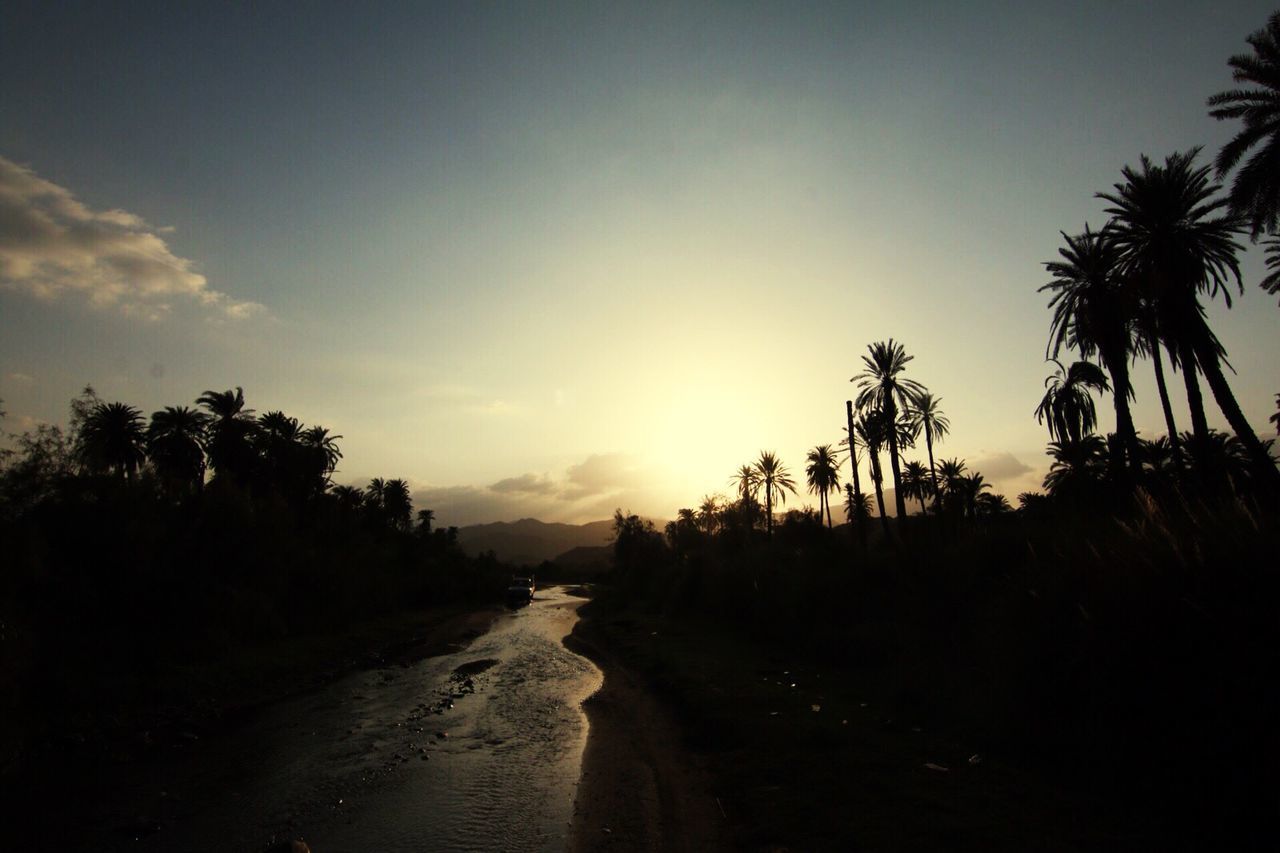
left=564, top=619, right=731, bottom=853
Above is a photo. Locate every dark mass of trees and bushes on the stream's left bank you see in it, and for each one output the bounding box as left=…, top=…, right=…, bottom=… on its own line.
left=0, top=389, right=509, bottom=775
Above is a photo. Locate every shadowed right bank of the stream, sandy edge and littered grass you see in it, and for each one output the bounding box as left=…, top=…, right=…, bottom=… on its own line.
left=568, top=597, right=1171, bottom=852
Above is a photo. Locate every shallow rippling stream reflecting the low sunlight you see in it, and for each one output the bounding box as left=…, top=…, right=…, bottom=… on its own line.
left=68, top=588, right=603, bottom=853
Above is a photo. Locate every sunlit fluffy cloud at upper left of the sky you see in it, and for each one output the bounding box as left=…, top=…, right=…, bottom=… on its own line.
left=0, top=156, right=265, bottom=320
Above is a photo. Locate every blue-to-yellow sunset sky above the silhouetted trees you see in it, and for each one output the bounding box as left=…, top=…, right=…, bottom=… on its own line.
left=0, top=0, right=1280, bottom=524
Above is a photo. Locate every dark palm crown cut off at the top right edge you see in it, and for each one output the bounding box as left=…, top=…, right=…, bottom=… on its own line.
left=1208, top=12, right=1280, bottom=245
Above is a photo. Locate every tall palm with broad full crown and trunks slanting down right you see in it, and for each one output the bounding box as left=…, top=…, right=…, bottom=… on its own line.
left=1098, top=149, right=1280, bottom=488
